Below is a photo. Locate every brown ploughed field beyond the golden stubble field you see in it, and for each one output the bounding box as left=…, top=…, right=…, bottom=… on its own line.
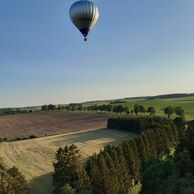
left=0, top=111, right=108, bottom=140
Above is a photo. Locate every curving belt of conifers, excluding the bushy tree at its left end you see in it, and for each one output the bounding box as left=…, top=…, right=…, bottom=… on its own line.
left=86, top=117, right=178, bottom=194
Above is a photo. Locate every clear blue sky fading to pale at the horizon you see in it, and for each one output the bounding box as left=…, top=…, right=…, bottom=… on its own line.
left=0, top=0, right=194, bottom=107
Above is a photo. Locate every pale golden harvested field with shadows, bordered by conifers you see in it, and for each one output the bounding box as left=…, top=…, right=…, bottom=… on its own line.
left=0, top=128, right=135, bottom=194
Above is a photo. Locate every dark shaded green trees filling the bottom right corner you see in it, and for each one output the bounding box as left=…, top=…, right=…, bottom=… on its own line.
left=141, top=122, right=194, bottom=194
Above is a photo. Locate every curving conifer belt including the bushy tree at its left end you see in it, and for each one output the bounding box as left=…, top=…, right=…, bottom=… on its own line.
left=53, top=117, right=179, bottom=194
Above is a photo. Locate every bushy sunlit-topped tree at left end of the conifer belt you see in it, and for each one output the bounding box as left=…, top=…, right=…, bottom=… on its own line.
left=53, top=145, right=90, bottom=194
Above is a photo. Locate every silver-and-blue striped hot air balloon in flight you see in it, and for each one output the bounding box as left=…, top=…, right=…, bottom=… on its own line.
left=69, top=0, right=99, bottom=41
